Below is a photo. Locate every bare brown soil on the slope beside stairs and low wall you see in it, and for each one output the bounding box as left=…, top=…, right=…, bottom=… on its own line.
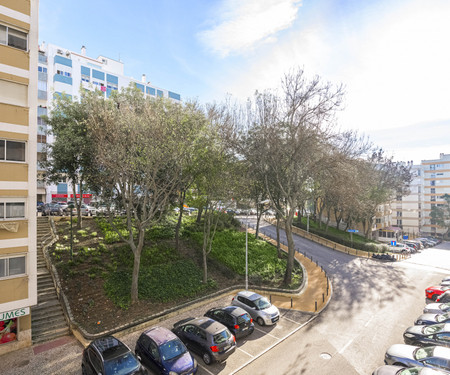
left=49, top=218, right=244, bottom=334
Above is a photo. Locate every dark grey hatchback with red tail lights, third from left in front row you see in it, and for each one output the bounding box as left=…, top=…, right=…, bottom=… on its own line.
left=172, top=317, right=236, bottom=365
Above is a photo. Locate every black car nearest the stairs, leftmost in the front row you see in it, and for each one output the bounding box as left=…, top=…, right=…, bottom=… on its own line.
left=81, top=336, right=148, bottom=375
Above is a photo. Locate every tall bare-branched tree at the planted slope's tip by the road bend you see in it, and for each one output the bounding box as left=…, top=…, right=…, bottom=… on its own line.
left=244, top=70, right=343, bottom=284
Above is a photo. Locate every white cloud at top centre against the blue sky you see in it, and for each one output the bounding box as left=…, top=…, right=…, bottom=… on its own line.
left=198, top=0, right=300, bottom=57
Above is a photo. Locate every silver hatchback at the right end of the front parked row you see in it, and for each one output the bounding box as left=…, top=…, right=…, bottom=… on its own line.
left=231, top=290, right=280, bottom=326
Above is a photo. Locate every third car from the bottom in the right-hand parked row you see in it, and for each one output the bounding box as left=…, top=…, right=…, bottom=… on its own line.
left=403, top=323, right=450, bottom=347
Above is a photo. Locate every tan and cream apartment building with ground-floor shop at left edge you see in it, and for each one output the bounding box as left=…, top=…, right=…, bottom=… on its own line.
left=0, top=0, right=38, bottom=354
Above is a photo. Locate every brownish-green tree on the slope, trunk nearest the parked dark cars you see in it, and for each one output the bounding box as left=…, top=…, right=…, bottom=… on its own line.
left=88, top=88, right=200, bottom=304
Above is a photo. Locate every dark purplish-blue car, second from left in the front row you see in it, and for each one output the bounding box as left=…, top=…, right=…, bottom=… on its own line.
left=134, top=327, right=197, bottom=375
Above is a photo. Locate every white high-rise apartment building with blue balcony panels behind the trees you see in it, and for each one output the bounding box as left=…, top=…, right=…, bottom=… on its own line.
left=37, top=43, right=181, bottom=202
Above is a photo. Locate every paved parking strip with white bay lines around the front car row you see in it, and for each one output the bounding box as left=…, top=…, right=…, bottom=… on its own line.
left=115, top=296, right=314, bottom=375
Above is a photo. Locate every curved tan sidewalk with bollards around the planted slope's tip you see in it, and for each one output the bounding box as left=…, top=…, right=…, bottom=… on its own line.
left=249, top=229, right=332, bottom=313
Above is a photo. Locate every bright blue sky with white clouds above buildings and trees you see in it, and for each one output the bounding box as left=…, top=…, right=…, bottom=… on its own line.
left=39, top=0, right=450, bottom=164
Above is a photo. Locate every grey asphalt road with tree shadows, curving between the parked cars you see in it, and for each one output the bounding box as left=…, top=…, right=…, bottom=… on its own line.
left=238, top=219, right=450, bottom=375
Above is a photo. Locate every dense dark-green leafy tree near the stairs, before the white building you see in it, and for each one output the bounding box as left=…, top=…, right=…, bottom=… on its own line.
left=43, top=94, right=94, bottom=229
